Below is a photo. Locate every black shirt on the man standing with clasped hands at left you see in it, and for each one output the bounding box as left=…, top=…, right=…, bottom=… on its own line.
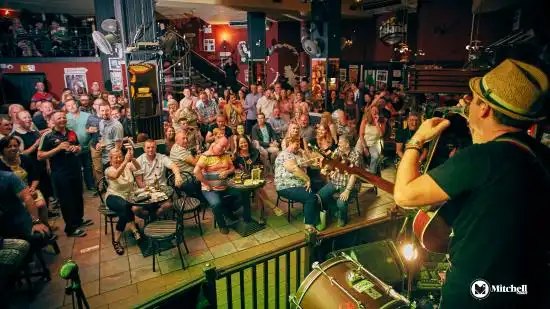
left=38, top=129, right=80, bottom=174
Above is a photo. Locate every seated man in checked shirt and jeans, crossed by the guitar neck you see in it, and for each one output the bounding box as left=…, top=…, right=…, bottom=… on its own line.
left=319, top=135, right=363, bottom=227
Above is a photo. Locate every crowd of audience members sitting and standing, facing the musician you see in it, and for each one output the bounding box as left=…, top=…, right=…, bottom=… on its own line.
left=0, top=75, right=432, bottom=296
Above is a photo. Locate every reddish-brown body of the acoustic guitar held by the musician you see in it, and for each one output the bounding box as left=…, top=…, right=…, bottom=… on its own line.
left=413, top=209, right=451, bottom=253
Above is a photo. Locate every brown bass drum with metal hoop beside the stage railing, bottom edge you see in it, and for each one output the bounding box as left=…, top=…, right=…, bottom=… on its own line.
left=290, top=256, right=410, bottom=309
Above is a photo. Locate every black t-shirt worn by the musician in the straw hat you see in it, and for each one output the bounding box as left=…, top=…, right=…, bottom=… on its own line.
left=428, top=134, right=550, bottom=309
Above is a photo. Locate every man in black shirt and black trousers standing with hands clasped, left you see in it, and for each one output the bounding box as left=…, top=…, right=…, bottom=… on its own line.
left=38, top=112, right=93, bottom=237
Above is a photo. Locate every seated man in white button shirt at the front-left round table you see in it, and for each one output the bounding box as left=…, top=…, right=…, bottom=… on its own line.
left=135, top=139, right=183, bottom=218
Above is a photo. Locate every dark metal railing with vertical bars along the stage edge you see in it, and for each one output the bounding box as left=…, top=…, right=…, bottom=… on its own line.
left=134, top=207, right=399, bottom=309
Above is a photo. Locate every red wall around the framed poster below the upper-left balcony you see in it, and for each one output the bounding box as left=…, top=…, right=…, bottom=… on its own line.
left=0, top=61, right=103, bottom=98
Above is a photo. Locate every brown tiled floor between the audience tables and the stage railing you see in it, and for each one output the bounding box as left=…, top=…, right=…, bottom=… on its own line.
left=12, top=169, right=395, bottom=309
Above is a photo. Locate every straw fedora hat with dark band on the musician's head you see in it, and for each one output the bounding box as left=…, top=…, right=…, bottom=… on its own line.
left=470, top=59, right=548, bottom=121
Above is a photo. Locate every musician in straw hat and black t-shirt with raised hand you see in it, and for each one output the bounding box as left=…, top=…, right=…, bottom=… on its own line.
left=394, top=59, right=550, bottom=309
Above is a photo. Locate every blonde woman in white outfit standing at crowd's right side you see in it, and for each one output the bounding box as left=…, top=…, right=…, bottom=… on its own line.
left=359, top=105, right=386, bottom=174
